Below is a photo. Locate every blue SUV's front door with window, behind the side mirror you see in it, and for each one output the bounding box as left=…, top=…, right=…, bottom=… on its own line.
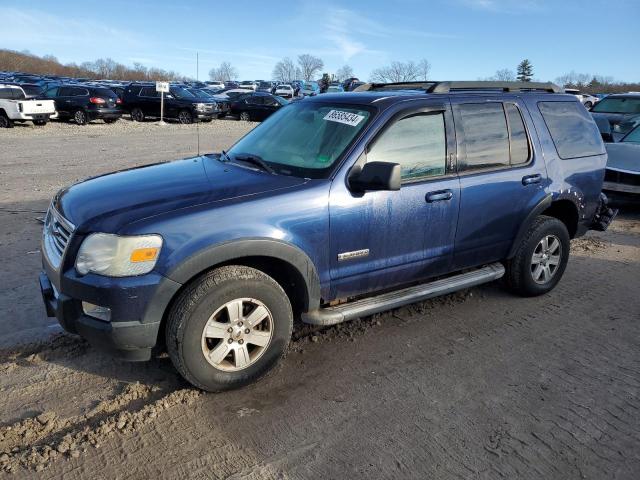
left=329, top=101, right=460, bottom=298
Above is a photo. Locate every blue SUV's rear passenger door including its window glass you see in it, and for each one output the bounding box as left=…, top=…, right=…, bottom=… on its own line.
left=451, top=96, right=548, bottom=269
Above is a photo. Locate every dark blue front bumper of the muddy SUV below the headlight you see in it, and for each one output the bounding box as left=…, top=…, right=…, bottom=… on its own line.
left=39, top=261, right=180, bottom=361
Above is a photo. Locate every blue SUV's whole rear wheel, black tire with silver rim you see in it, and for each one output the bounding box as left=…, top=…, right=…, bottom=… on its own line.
left=504, top=215, right=570, bottom=297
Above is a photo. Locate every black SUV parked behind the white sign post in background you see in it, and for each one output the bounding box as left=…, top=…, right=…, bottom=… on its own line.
left=122, top=83, right=221, bottom=124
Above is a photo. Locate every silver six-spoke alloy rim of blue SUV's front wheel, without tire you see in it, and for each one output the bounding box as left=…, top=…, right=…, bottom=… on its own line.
left=202, top=298, right=274, bottom=372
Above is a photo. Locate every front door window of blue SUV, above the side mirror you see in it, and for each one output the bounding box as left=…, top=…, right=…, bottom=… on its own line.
left=367, top=113, right=447, bottom=181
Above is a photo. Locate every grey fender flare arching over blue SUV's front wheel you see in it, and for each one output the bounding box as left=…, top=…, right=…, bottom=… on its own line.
left=165, top=238, right=320, bottom=310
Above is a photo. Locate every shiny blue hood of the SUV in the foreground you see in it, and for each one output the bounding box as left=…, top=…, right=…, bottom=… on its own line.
left=54, top=156, right=305, bottom=233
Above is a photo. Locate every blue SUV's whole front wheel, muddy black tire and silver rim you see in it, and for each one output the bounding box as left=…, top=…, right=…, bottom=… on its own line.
left=165, top=265, right=293, bottom=392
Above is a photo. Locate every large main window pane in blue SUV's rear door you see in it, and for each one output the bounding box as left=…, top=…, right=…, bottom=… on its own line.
left=458, top=102, right=509, bottom=171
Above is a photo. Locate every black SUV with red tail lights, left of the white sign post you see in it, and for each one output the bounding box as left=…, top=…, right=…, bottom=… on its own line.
left=44, top=85, right=122, bottom=125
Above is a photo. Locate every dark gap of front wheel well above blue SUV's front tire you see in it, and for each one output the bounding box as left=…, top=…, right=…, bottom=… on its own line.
left=156, top=256, right=309, bottom=349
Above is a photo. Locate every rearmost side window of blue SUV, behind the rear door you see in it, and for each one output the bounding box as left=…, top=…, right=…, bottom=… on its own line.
left=538, top=102, right=604, bottom=160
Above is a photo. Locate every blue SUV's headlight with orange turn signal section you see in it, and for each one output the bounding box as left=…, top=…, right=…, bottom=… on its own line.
left=76, top=233, right=162, bottom=277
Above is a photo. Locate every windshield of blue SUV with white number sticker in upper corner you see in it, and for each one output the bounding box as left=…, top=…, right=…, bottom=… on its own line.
left=227, top=102, right=373, bottom=178
